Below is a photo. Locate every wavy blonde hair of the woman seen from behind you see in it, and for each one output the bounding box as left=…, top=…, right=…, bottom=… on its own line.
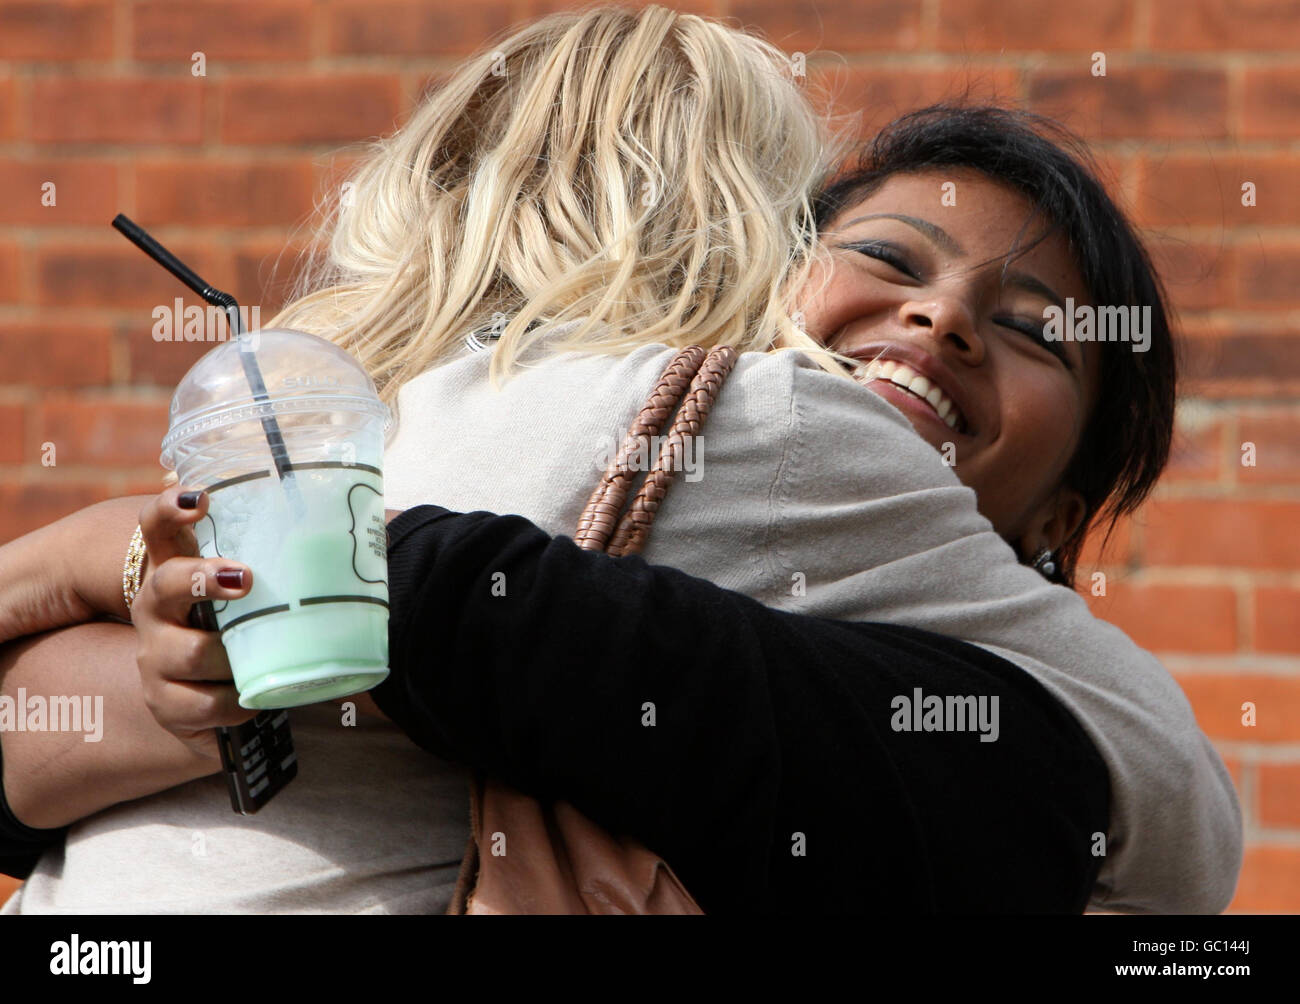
left=268, top=7, right=842, bottom=404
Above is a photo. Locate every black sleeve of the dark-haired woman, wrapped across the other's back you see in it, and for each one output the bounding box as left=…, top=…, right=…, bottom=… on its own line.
left=372, top=506, right=1109, bottom=913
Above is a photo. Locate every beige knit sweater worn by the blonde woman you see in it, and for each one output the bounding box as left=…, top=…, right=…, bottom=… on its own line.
left=5, top=332, right=1242, bottom=912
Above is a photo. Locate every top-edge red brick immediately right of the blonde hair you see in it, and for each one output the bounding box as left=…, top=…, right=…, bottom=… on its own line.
left=728, top=0, right=920, bottom=53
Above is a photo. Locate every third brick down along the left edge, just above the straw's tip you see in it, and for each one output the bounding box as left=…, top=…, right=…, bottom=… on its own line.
left=0, top=157, right=118, bottom=224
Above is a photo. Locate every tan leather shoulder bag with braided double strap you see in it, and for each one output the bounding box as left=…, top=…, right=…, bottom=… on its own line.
left=447, top=346, right=736, bottom=914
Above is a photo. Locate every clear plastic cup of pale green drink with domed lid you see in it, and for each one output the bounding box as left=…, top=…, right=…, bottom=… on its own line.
left=161, top=329, right=390, bottom=709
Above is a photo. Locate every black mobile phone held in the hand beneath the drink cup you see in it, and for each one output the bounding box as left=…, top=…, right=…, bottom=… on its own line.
left=190, top=600, right=298, bottom=815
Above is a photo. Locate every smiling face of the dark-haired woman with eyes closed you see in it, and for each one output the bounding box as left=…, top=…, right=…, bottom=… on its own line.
left=801, top=169, right=1099, bottom=555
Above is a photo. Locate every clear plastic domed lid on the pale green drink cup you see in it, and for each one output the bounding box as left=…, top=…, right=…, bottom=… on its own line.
left=160, top=328, right=391, bottom=469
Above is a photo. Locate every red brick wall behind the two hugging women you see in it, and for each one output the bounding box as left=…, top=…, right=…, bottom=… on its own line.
left=0, top=0, right=1300, bottom=912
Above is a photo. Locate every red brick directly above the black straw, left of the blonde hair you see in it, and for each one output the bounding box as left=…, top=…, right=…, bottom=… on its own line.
left=135, top=157, right=312, bottom=226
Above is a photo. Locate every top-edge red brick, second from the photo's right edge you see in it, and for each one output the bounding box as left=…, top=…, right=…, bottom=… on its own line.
left=939, top=0, right=1134, bottom=50
